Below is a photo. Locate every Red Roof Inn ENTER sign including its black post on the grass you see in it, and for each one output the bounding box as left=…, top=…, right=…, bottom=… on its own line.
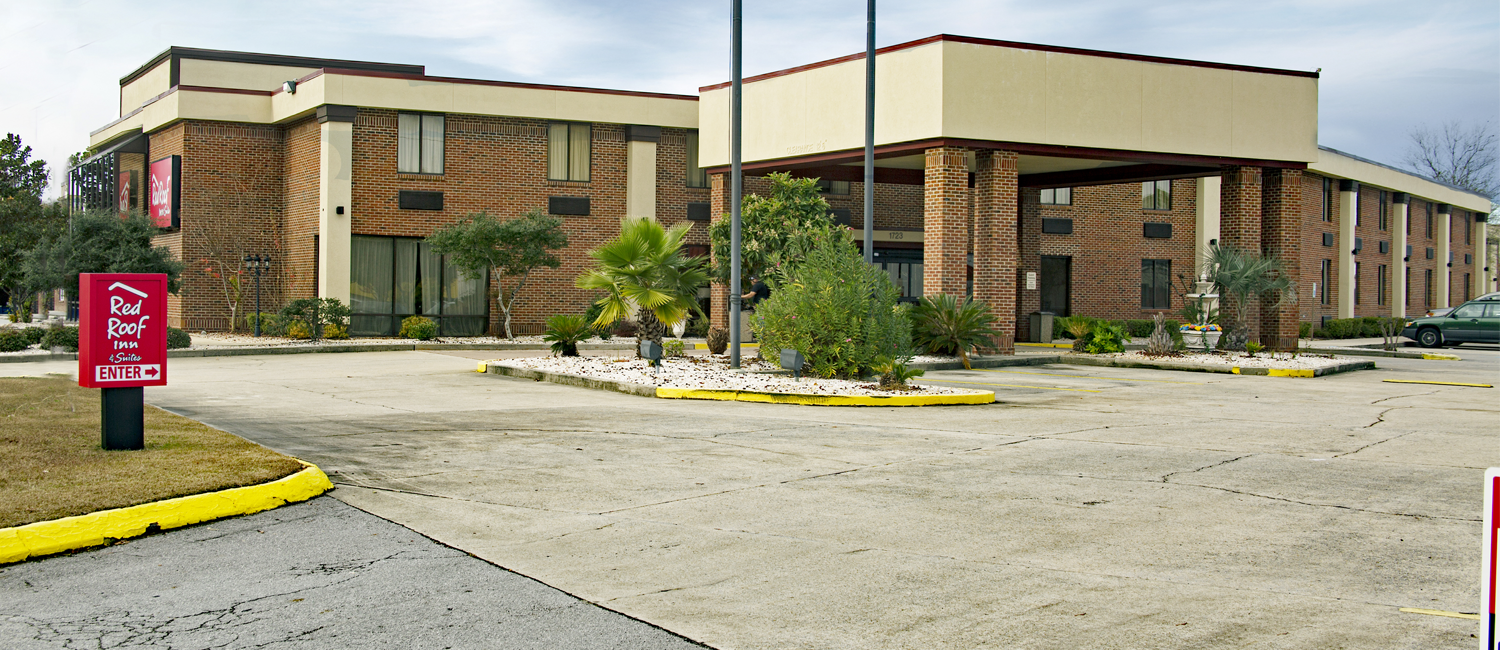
left=78, top=273, right=167, bottom=449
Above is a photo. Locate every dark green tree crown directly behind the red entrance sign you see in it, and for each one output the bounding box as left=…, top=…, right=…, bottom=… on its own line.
left=23, top=210, right=183, bottom=296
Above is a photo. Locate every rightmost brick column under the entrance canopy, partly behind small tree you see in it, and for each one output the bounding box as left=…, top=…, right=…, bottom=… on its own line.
left=1260, top=168, right=1302, bottom=351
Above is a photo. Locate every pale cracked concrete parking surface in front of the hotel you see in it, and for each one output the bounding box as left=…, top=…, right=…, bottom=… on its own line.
left=8, top=348, right=1500, bottom=648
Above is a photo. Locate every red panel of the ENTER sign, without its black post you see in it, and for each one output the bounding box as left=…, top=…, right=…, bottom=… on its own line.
left=78, top=273, right=167, bottom=389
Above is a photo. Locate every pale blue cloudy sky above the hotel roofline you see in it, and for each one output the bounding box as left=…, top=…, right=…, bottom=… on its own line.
left=0, top=0, right=1500, bottom=195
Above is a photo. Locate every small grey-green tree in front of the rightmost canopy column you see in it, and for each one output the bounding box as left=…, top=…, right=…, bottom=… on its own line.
left=1203, top=245, right=1298, bottom=350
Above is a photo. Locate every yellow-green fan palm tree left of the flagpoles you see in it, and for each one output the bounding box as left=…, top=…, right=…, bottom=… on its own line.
left=578, top=216, right=708, bottom=354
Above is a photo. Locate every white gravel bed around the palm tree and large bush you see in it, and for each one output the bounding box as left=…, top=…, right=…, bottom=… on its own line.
left=486, top=356, right=987, bottom=395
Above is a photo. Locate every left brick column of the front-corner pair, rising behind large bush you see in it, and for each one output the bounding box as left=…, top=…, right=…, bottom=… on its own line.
left=923, top=147, right=972, bottom=300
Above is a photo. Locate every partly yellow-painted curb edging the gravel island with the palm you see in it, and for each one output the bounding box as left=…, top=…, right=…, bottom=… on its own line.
left=480, top=363, right=995, bottom=407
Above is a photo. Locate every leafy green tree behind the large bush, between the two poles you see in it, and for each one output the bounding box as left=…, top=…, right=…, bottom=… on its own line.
left=708, top=173, right=834, bottom=293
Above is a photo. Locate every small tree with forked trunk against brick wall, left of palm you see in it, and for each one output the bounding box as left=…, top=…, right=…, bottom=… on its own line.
left=428, top=209, right=567, bottom=339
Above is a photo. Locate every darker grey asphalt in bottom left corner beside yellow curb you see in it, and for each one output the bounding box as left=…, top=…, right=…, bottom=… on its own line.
left=0, top=497, right=702, bottom=650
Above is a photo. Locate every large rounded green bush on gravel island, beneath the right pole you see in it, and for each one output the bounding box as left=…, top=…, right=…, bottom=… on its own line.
left=752, top=231, right=912, bottom=377
